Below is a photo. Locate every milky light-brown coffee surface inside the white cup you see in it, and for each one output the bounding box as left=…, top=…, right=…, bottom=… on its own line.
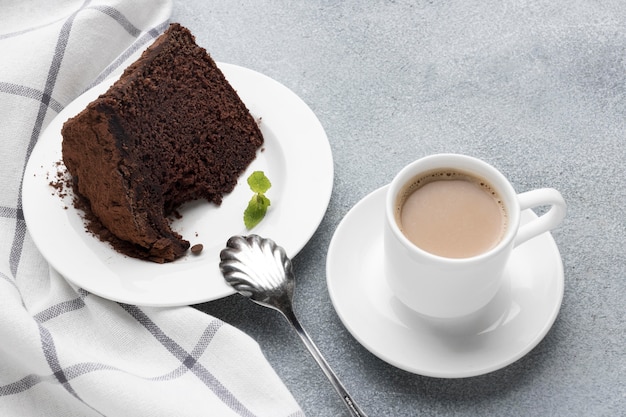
left=395, top=168, right=507, bottom=258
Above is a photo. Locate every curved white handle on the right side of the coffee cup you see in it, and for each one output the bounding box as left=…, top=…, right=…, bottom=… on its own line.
left=515, top=188, right=566, bottom=246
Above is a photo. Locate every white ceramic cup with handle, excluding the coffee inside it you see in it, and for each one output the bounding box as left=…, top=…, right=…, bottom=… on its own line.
left=384, top=154, right=566, bottom=318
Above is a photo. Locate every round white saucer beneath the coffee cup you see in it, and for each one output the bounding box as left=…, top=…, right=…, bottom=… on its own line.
left=326, top=187, right=564, bottom=378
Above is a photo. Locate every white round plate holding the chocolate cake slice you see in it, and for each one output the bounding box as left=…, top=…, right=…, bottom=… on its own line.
left=23, top=64, right=333, bottom=306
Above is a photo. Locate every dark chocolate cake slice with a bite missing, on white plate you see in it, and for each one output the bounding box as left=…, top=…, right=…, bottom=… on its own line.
left=62, top=24, right=263, bottom=262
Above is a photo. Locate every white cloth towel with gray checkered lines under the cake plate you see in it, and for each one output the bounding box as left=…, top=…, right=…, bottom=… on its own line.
left=0, top=0, right=304, bottom=417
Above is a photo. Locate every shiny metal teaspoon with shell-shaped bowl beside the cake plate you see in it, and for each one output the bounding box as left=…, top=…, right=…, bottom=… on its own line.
left=220, top=235, right=367, bottom=417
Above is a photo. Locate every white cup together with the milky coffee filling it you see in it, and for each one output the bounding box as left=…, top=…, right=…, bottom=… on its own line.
left=384, top=154, right=565, bottom=319
